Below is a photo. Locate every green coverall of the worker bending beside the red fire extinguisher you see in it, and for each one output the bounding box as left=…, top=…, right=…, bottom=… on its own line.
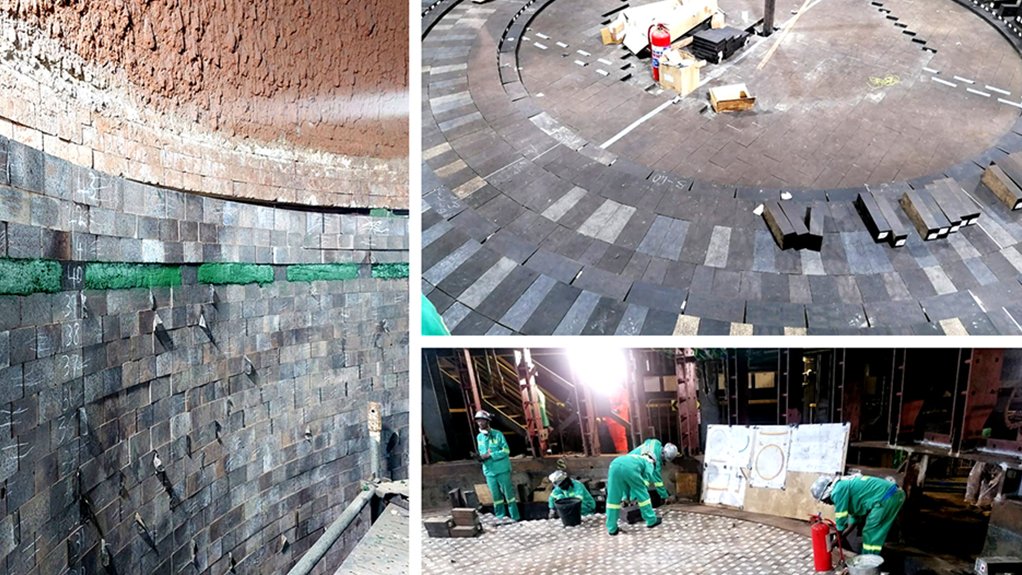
left=831, top=475, right=904, bottom=555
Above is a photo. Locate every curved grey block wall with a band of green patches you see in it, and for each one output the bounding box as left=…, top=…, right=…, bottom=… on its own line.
left=0, top=139, right=408, bottom=575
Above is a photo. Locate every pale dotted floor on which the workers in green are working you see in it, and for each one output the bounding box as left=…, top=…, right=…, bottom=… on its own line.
left=422, top=508, right=814, bottom=575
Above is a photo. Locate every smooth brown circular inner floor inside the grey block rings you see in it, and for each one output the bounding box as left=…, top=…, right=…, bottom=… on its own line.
left=518, top=0, right=1022, bottom=188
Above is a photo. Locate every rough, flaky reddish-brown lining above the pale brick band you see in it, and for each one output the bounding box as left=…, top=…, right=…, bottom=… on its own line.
left=7, top=0, right=408, bottom=158
